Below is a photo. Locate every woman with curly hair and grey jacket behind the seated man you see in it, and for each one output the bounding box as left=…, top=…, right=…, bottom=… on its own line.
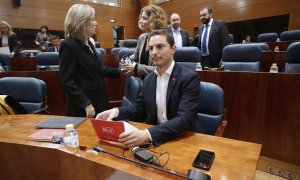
left=122, top=5, right=167, bottom=76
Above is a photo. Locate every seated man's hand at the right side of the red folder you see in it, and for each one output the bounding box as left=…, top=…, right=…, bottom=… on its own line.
left=119, top=130, right=151, bottom=148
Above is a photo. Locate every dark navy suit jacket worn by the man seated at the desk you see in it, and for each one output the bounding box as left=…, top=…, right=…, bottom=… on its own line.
left=118, top=63, right=200, bottom=145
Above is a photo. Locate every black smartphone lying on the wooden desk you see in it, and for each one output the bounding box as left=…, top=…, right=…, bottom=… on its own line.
left=193, top=150, right=215, bottom=170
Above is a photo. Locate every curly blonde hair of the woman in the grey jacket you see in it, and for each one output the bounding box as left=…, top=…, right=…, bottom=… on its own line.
left=140, top=5, right=167, bottom=31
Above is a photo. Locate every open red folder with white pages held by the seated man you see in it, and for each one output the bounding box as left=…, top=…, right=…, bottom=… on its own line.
left=91, top=119, right=137, bottom=142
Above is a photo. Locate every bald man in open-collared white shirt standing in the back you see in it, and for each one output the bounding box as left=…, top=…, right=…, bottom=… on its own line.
left=168, top=13, right=190, bottom=47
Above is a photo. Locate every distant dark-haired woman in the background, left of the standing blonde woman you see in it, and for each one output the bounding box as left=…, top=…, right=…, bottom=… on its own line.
left=34, top=25, right=52, bottom=49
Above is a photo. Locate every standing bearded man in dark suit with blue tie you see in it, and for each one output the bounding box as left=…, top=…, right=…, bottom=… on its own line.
left=194, top=7, right=229, bottom=68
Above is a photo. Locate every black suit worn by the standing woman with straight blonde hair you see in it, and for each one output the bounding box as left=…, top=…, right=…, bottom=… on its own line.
left=59, top=38, right=120, bottom=117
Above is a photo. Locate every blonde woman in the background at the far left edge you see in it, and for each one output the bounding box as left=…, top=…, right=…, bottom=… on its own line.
left=0, top=21, right=18, bottom=57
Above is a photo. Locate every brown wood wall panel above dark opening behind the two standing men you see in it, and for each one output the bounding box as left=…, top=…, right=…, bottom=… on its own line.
left=159, top=0, right=300, bottom=35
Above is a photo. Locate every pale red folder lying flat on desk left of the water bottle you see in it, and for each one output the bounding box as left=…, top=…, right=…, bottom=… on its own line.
left=27, top=129, right=65, bottom=141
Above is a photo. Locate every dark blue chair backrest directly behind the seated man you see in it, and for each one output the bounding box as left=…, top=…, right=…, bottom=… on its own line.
left=195, top=81, right=224, bottom=135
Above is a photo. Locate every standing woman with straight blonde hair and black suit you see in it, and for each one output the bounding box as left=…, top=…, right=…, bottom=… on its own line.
left=59, top=4, right=120, bottom=117
